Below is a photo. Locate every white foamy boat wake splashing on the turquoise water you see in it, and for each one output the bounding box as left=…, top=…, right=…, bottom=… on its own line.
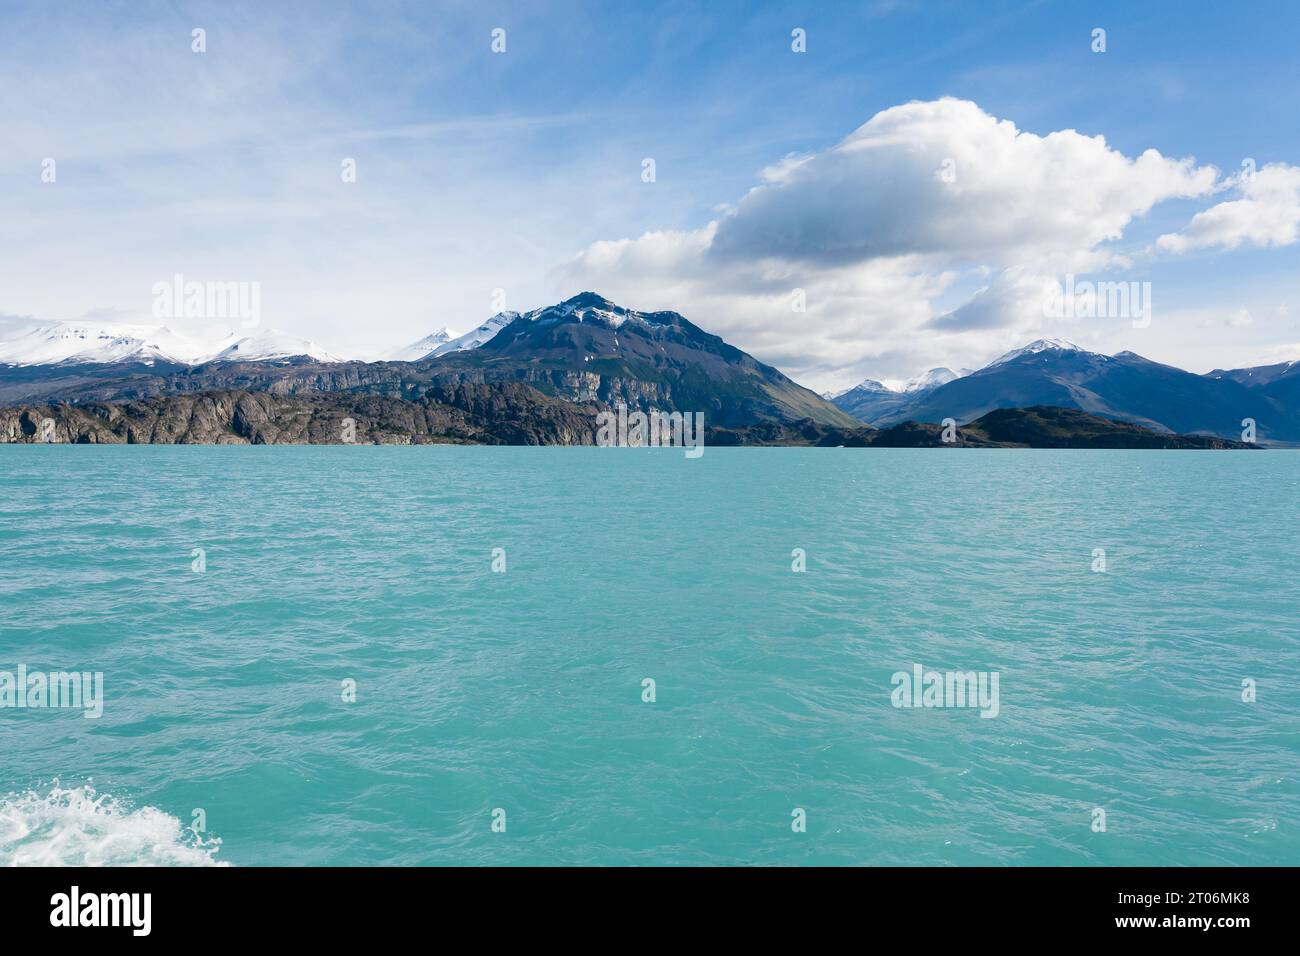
left=0, top=780, right=228, bottom=866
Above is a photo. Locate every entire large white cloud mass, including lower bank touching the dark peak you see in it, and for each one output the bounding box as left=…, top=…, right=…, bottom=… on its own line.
left=559, top=98, right=1216, bottom=382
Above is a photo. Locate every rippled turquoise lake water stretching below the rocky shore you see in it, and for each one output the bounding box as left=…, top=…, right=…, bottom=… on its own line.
left=0, top=445, right=1300, bottom=866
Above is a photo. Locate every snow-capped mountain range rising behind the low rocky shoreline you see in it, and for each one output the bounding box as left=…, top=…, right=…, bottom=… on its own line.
left=0, top=293, right=1300, bottom=444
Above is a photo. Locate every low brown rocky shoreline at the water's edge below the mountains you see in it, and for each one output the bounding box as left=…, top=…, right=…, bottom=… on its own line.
left=0, top=382, right=1258, bottom=449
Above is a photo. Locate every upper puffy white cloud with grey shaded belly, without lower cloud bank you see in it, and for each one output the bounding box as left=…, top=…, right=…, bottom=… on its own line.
left=711, top=99, right=1217, bottom=265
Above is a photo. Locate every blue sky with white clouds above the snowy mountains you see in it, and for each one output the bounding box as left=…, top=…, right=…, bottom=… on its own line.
left=0, top=0, right=1300, bottom=388
